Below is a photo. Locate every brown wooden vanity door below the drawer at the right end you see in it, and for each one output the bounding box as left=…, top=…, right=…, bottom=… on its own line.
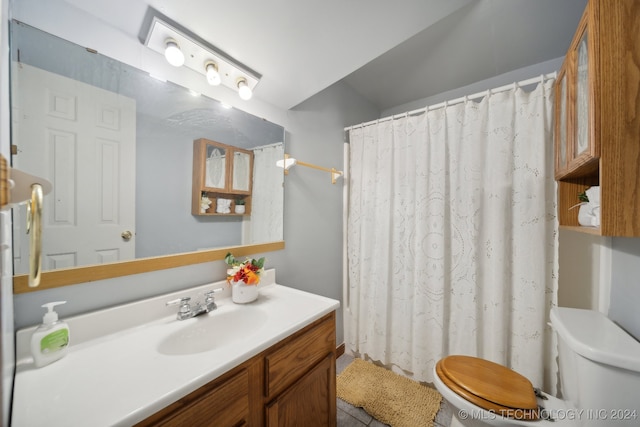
left=266, top=353, right=337, bottom=427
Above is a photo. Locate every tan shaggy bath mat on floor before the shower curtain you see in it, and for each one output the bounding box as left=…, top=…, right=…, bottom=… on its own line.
left=336, top=359, right=442, bottom=427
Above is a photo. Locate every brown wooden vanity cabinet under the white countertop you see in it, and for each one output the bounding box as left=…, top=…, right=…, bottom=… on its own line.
left=137, top=312, right=337, bottom=427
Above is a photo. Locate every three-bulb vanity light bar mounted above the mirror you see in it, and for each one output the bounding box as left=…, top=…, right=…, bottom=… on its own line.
left=144, top=12, right=262, bottom=100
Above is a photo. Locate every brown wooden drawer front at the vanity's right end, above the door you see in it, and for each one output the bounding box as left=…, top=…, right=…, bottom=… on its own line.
left=265, top=313, right=336, bottom=397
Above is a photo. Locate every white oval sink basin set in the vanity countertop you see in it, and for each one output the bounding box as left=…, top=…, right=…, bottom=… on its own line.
left=158, top=306, right=267, bottom=355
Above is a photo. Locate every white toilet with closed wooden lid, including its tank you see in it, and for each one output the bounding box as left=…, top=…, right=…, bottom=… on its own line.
left=434, top=307, right=640, bottom=427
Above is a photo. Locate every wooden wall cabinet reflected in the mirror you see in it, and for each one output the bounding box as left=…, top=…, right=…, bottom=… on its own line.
left=191, top=138, right=253, bottom=215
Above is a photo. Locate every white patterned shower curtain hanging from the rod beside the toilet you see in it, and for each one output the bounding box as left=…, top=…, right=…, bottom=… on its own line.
left=345, top=80, right=557, bottom=391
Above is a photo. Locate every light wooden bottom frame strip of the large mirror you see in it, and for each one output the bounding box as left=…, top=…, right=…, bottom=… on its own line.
left=13, top=240, right=284, bottom=295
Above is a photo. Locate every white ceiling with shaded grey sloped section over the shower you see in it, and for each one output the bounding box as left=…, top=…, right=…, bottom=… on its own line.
left=66, top=0, right=587, bottom=110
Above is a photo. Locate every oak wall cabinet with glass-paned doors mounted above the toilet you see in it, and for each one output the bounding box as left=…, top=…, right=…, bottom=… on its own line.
left=555, top=0, right=640, bottom=237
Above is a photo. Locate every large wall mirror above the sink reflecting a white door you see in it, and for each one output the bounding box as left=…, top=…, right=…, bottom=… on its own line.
left=11, top=21, right=284, bottom=292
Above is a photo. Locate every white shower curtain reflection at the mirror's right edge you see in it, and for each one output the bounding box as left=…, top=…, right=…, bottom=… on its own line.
left=242, top=142, right=284, bottom=245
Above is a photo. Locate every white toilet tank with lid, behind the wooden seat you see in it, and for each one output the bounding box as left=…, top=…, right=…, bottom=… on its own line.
left=551, top=307, right=640, bottom=426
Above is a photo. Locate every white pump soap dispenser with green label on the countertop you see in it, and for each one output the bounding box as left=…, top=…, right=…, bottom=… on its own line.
left=31, top=301, right=69, bottom=368
